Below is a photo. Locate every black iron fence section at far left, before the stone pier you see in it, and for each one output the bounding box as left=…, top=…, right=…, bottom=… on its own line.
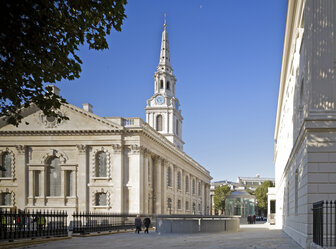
left=0, top=211, right=68, bottom=241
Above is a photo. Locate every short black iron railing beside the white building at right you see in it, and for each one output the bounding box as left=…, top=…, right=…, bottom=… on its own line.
left=313, top=201, right=336, bottom=247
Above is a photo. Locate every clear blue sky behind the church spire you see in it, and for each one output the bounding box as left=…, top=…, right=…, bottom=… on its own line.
left=58, top=0, right=287, bottom=181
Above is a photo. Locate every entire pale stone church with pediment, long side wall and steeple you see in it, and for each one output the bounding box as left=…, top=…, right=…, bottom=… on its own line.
left=0, top=20, right=211, bottom=214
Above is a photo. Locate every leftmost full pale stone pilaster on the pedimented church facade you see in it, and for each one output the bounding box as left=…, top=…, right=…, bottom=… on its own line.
left=15, top=145, right=28, bottom=210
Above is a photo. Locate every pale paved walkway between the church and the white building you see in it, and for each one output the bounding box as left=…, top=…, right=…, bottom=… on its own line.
left=8, top=224, right=302, bottom=249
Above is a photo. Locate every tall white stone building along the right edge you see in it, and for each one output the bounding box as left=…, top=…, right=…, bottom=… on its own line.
left=270, top=0, right=336, bottom=248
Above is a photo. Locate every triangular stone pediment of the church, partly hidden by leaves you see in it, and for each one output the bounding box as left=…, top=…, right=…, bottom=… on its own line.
left=0, top=104, right=123, bottom=131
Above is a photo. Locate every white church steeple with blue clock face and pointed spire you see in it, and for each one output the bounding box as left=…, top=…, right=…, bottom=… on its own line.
left=146, top=15, right=184, bottom=150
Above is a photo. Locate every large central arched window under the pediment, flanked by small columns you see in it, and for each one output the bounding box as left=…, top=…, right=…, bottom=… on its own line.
left=47, top=157, right=62, bottom=196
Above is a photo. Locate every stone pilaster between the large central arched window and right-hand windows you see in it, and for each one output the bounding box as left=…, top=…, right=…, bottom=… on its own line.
left=74, top=144, right=87, bottom=212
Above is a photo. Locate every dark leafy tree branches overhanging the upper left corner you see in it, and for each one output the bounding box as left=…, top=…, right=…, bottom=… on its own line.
left=0, top=0, right=127, bottom=125
